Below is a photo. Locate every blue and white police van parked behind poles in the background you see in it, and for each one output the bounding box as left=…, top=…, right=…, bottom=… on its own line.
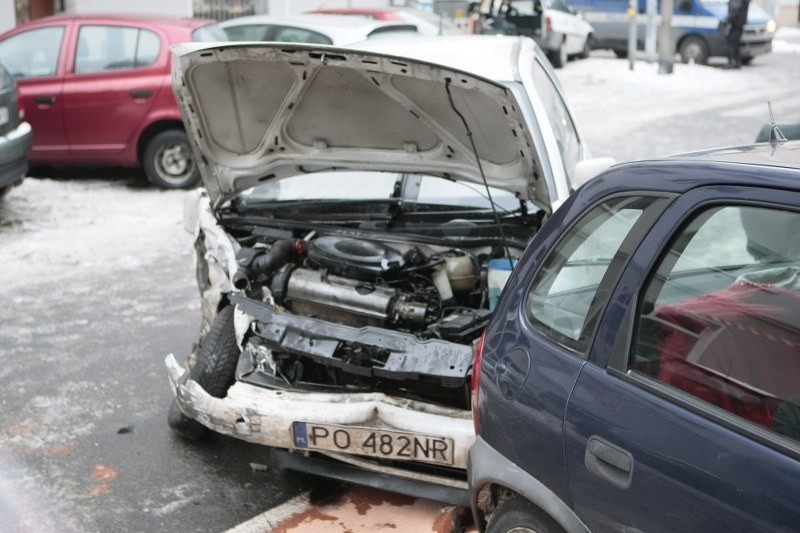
left=571, top=0, right=776, bottom=64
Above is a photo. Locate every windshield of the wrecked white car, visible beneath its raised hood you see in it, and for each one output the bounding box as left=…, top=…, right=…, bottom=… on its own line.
left=236, top=171, right=535, bottom=211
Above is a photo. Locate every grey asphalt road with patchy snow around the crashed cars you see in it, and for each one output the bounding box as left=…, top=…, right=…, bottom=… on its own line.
left=0, top=37, right=800, bottom=532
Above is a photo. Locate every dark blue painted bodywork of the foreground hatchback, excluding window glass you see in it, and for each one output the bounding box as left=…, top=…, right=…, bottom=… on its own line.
left=469, top=142, right=800, bottom=532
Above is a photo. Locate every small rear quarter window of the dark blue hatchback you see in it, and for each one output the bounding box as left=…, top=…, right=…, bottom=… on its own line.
left=526, top=198, right=651, bottom=349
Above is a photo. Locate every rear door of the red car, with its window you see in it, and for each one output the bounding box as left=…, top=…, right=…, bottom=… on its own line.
left=63, top=23, right=169, bottom=161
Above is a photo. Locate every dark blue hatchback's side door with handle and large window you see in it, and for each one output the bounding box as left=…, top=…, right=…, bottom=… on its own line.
left=565, top=187, right=800, bottom=532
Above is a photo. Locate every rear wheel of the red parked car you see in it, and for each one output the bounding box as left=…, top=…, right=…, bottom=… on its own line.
left=142, top=129, right=200, bottom=189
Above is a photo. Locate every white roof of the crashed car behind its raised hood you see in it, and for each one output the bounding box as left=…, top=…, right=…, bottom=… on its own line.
left=348, top=35, right=524, bottom=81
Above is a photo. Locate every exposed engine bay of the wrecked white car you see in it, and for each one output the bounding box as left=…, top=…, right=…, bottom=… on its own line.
left=231, top=234, right=521, bottom=408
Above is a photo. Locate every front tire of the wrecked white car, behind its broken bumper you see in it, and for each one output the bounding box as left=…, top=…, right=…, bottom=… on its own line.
left=167, top=306, right=240, bottom=440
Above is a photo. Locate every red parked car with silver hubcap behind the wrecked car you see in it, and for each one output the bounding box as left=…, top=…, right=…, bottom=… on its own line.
left=0, top=16, right=227, bottom=188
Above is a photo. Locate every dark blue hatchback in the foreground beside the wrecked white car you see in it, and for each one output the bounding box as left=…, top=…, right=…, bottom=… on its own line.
left=469, top=142, right=800, bottom=532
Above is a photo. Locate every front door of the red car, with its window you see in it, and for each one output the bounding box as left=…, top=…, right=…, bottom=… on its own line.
left=0, top=23, right=70, bottom=162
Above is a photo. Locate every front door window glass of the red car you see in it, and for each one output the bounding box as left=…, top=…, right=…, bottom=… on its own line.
left=0, top=26, right=64, bottom=78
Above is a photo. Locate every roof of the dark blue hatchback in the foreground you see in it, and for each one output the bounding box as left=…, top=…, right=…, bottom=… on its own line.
left=584, top=141, right=800, bottom=197
